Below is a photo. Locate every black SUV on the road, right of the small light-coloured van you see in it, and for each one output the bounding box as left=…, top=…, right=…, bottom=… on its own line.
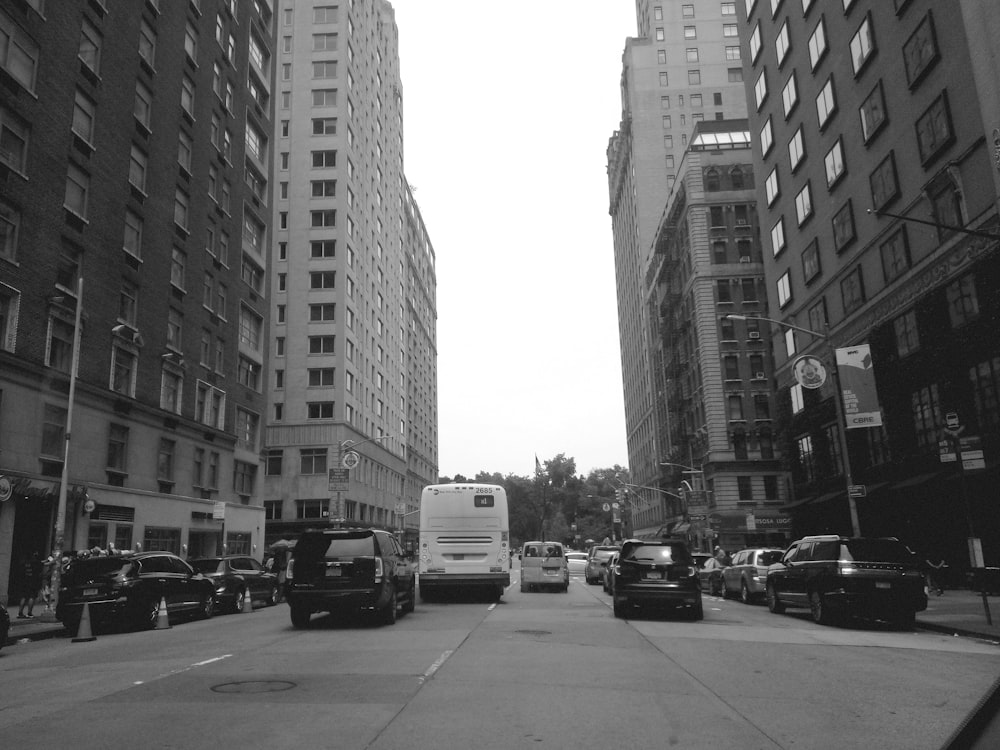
left=609, top=539, right=704, bottom=620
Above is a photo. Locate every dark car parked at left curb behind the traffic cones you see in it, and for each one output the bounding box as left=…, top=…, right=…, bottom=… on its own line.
left=56, top=552, right=215, bottom=633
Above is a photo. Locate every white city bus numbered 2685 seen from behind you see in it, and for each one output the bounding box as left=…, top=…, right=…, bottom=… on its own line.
left=418, top=483, right=511, bottom=601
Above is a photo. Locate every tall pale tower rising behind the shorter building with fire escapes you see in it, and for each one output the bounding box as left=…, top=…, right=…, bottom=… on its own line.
left=607, top=0, right=746, bottom=533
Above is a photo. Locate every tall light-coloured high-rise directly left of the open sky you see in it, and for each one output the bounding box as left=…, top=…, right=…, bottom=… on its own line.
left=264, top=0, right=437, bottom=541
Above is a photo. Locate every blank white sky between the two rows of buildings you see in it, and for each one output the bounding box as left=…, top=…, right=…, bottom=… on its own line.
left=392, top=0, right=636, bottom=477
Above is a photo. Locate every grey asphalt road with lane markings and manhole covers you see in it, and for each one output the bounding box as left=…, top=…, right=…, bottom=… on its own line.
left=0, top=570, right=1000, bottom=750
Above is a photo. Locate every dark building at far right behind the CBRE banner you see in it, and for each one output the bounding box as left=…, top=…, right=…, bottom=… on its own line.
left=739, top=0, right=1000, bottom=566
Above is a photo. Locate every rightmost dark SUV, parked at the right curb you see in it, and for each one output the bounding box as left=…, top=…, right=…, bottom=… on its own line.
left=766, top=535, right=927, bottom=628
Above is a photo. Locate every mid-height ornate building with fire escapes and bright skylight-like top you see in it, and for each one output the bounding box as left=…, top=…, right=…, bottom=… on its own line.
left=649, top=119, right=791, bottom=551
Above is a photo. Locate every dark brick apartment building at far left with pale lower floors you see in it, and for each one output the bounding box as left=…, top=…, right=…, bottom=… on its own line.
left=0, top=0, right=274, bottom=596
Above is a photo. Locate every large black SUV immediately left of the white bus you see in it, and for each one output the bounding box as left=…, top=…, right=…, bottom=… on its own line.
left=285, top=529, right=417, bottom=628
